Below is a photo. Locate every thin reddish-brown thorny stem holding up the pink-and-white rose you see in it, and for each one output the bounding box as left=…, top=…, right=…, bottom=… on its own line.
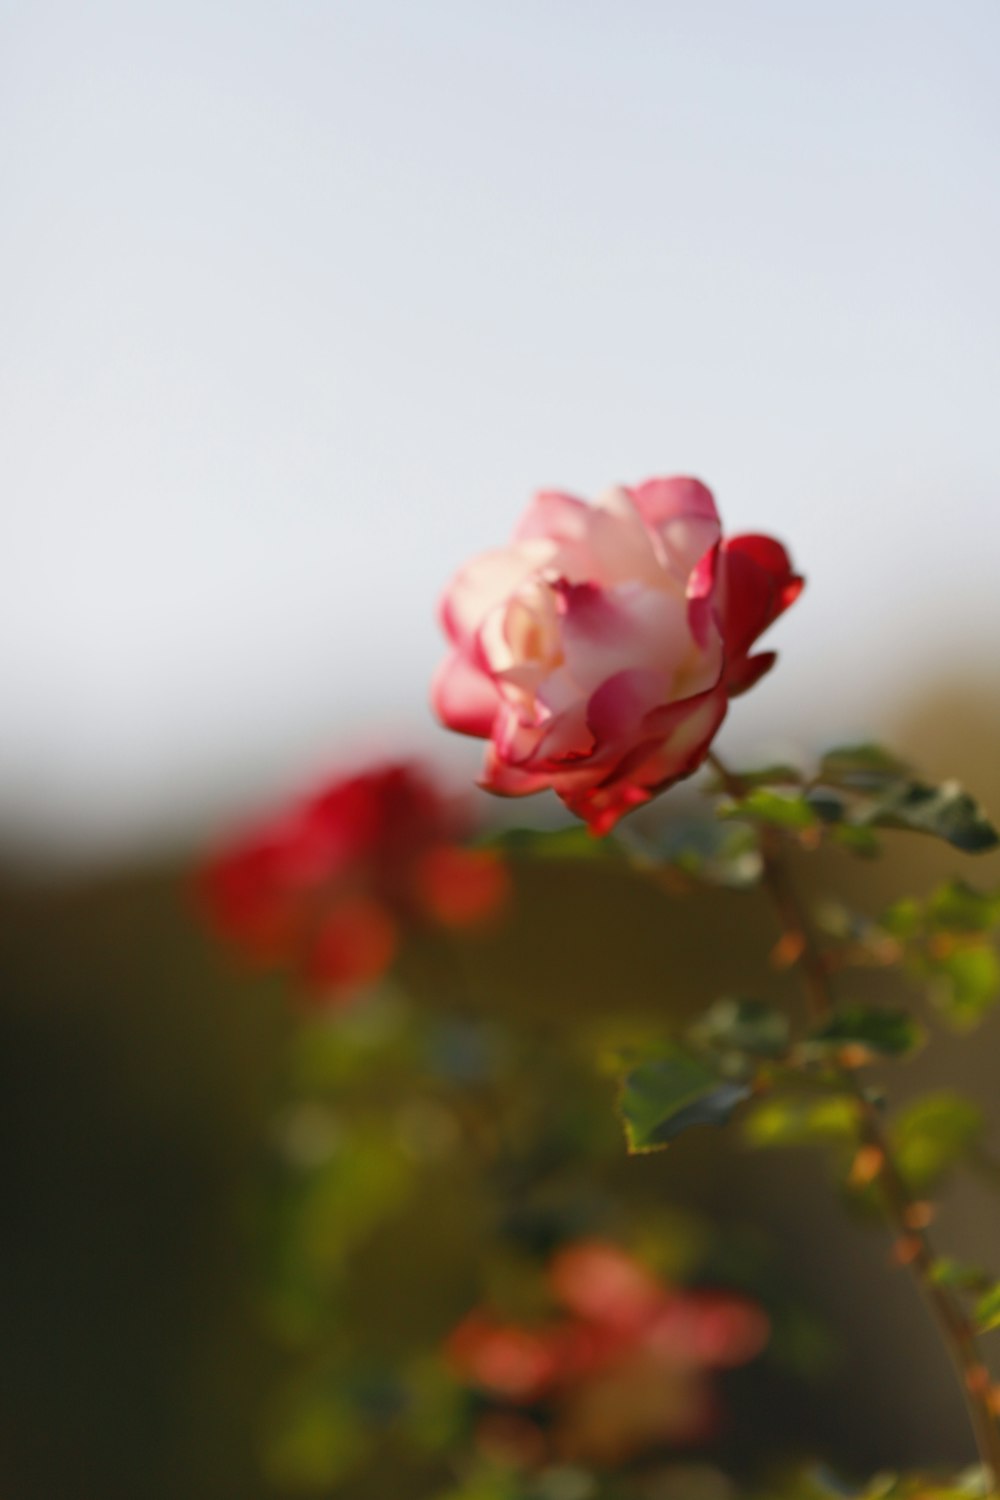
left=709, top=753, right=1000, bottom=1496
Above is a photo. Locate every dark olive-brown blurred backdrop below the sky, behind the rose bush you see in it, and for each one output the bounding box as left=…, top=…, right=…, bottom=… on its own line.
left=0, top=693, right=1000, bottom=1500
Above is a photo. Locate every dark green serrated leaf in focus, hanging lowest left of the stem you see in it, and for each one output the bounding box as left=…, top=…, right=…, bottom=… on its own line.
left=619, top=1044, right=751, bottom=1152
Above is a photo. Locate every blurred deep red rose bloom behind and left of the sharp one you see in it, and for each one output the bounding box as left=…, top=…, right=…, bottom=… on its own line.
left=199, top=764, right=507, bottom=1001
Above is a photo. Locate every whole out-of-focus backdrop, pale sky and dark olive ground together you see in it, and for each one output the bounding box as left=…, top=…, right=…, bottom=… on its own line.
left=0, top=0, right=1000, bottom=1500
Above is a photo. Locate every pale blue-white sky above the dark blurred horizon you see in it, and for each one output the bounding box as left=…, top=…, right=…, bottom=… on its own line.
left=0, top=0, right=1000, bottom=851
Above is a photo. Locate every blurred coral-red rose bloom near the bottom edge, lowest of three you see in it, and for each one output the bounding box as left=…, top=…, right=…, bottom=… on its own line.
left=445, top=1241, right=769, bottom=1466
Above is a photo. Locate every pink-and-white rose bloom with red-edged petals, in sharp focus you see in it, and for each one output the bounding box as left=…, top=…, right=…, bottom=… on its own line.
left=432, top=479, right=802, bottom=834
